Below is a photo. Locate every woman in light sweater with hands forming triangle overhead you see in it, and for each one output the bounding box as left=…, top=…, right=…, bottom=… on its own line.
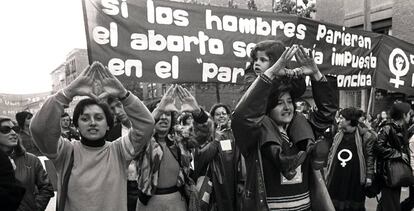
left=30, top=62, right=154, bottom=211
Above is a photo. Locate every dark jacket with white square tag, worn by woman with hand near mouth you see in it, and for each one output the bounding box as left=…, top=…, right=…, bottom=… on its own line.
left=194, top=125, right=245, bottom=211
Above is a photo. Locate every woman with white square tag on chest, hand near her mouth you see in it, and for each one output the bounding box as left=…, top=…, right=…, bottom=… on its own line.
left=194, top=103, right=246, bottom=211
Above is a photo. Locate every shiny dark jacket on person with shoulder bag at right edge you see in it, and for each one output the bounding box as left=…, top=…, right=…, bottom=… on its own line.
left=374, top=119, right=410, bottom=184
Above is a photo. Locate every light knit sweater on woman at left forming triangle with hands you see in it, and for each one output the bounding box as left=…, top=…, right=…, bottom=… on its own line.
left=30, top=92, right=154, bottom=211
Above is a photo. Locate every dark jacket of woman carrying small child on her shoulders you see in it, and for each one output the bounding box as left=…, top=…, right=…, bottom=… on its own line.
left=232, top=76, right=338, bottom=210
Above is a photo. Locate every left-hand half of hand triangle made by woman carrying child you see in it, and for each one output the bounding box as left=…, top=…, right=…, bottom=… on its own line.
left=264, top=46, right=298, bottom=79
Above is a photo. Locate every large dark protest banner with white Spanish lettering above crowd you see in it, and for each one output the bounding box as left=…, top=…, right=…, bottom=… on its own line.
left=83, top=0, right=414, bottom=93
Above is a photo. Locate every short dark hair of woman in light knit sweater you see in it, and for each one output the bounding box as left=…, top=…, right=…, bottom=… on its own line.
left=73, top=98, right=114, bottom=129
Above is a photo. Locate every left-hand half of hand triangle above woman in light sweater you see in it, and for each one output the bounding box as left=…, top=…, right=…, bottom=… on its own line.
left=63, top=63, right=98, bottom=99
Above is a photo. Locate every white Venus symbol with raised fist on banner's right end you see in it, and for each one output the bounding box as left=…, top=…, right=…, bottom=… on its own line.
left=388, top=48, right=410, bottom=88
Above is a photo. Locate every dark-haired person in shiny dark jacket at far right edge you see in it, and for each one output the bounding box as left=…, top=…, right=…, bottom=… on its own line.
left=374, top=103, right=411, bottom=211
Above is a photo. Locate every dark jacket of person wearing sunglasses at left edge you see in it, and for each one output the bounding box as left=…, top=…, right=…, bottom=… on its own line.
left=12, top=152, right=54, bottom=211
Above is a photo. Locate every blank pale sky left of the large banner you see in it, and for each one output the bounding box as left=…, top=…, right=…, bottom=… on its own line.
left=0, top=0, right=86, bottom=94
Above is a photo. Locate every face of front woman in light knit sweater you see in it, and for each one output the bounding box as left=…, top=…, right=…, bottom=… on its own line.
left=78, top=105, right=109, bottom=141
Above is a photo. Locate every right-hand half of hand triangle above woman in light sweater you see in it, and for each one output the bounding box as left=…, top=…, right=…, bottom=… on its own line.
left=92, top=62, right=128, bottom=99
